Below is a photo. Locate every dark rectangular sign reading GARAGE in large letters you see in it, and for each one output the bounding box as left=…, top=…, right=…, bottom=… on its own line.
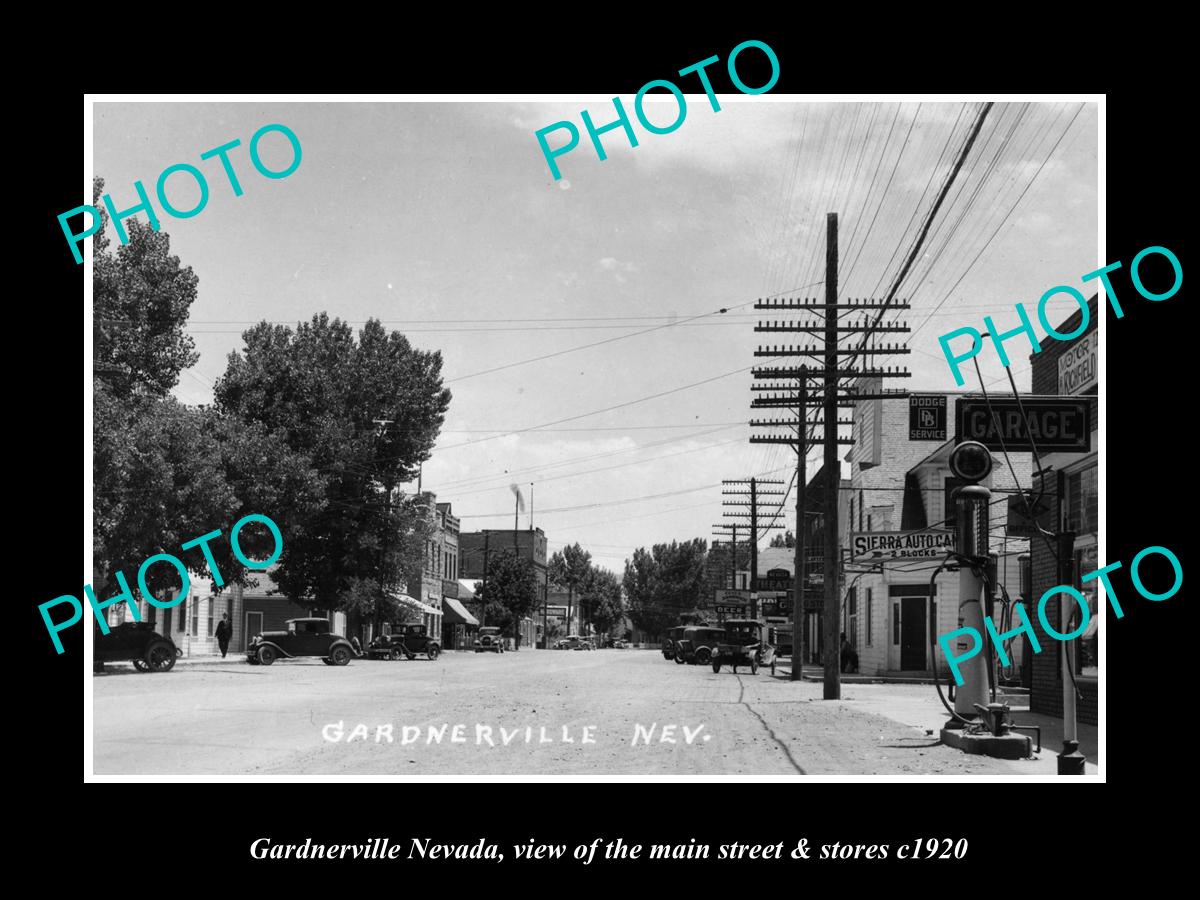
left=954, top=397, right=1092, bottom=454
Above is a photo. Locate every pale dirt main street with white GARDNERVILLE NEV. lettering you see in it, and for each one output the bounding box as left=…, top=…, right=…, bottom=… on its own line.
left=92, top=650, right=1046, bottom=776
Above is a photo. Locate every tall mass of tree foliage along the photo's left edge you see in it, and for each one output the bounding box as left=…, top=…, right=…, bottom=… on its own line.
left=92, top=179, right=322, bottom=607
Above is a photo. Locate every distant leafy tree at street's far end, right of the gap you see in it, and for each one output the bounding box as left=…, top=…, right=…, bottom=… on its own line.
left=623, top=538, right=708, bottom=635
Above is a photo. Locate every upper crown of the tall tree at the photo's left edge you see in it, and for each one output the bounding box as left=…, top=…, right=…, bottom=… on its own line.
left=91, top=179, right=199, bottom=400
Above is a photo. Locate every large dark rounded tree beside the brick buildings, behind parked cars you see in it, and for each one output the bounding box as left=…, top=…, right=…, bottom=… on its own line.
left=215, top=313, right=450, bottom=610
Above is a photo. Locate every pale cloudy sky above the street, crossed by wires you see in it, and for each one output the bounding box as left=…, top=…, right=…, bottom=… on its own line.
left=93, top=95, right=1109, bottom=572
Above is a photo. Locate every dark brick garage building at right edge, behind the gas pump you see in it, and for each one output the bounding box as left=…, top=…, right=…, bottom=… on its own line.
left=1026, top=294, right=1104, bottom=725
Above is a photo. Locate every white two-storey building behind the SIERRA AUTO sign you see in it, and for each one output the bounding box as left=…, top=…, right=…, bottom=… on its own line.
left=839, top=380, right=1031, bottom=677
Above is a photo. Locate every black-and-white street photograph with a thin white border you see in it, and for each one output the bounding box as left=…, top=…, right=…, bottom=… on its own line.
left=75, top=93, right=1113, bottom=780
